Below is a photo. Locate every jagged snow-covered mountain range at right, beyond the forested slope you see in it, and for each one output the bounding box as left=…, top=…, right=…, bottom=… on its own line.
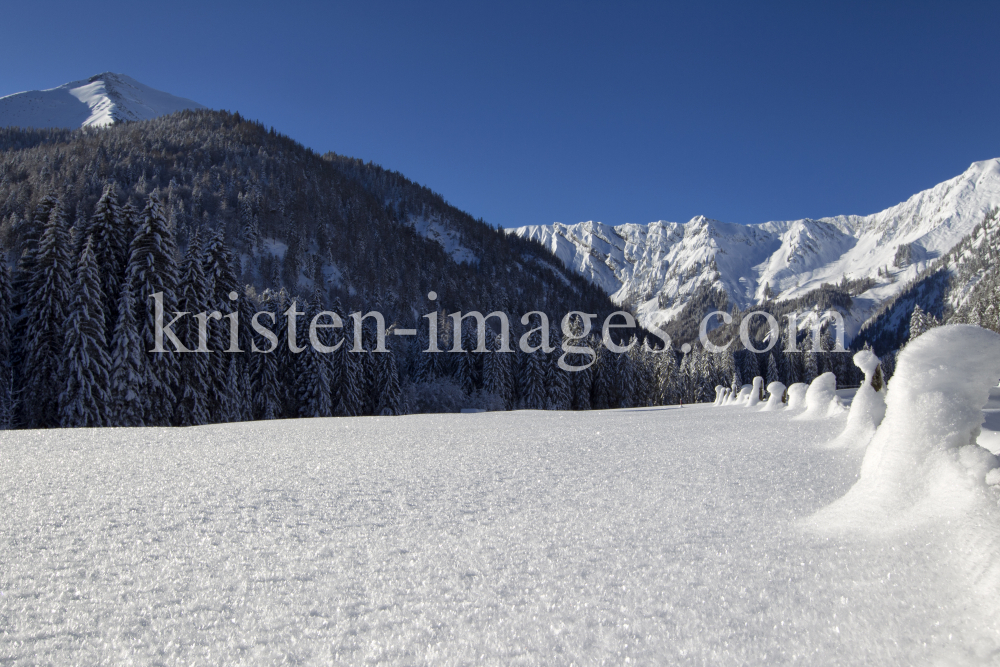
left=510, top=159, right=1000, bottom=337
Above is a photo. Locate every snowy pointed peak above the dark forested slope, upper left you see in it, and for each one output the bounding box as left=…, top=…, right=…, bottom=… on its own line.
left=0, top=72, right=206, bottom=129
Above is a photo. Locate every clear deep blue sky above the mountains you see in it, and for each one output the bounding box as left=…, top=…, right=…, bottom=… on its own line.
left=0, top=1, right=1000, bottom=227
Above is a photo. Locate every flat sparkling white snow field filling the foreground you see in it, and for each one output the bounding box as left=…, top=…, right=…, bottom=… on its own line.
left=0, top=406, right=1000, bottom=665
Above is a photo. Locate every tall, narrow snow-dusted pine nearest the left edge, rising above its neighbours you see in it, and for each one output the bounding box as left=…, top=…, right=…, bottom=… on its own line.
left=21, top=204, right=71, bottom=428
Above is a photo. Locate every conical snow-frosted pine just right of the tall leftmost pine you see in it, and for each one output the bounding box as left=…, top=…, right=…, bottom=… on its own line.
left=59, top=238, right=111, bottom=427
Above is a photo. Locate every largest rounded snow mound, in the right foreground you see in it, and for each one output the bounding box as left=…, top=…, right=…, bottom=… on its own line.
left=811, top=325, right=1000, bottom=536
